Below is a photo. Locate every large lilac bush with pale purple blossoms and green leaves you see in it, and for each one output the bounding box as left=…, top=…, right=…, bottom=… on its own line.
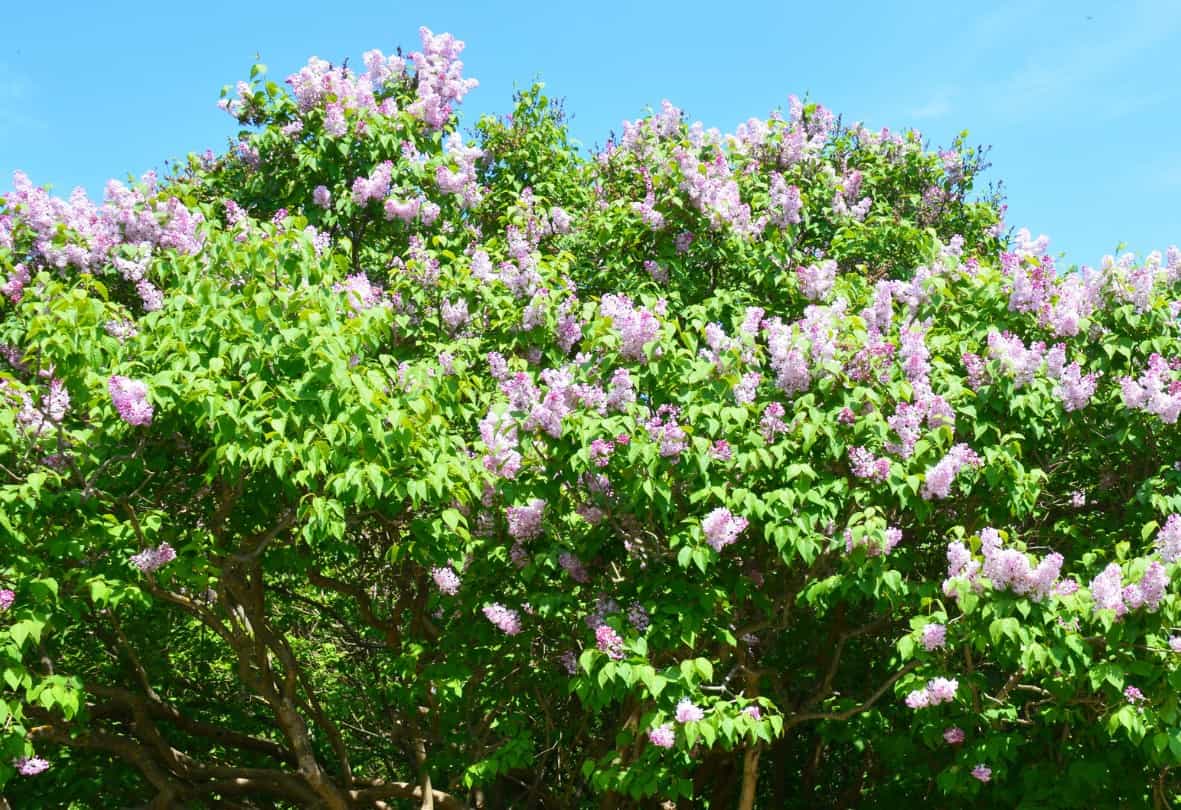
left=0, top=23, right=1181, bottom=810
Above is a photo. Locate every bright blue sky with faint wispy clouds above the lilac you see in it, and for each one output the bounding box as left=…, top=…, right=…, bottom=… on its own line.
left=0, top=0, right=1181, bottom=263
